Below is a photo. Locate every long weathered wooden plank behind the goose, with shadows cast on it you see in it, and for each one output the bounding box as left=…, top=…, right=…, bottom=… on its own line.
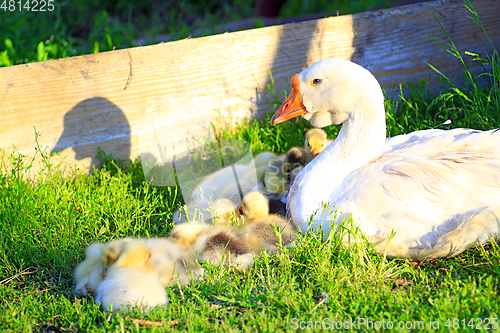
left=0, top=0, right=500, bottom=176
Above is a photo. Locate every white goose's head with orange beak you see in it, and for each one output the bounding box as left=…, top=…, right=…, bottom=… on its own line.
left=271, top=58, right=383, bottom=127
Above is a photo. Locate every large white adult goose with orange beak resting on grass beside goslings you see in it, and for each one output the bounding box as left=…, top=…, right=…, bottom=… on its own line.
left=271, top=59, right=500, bottom=260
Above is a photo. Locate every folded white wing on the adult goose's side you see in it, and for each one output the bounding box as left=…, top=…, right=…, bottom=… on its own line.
left=330, top=129, right=500, bottom=253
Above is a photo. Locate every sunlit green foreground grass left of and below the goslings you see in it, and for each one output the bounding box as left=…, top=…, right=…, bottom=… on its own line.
left=0, top=145, right=500, bottom=332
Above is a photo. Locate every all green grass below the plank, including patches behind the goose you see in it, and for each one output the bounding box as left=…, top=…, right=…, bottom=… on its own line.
left=0, top=1, right=500, bottom=332
